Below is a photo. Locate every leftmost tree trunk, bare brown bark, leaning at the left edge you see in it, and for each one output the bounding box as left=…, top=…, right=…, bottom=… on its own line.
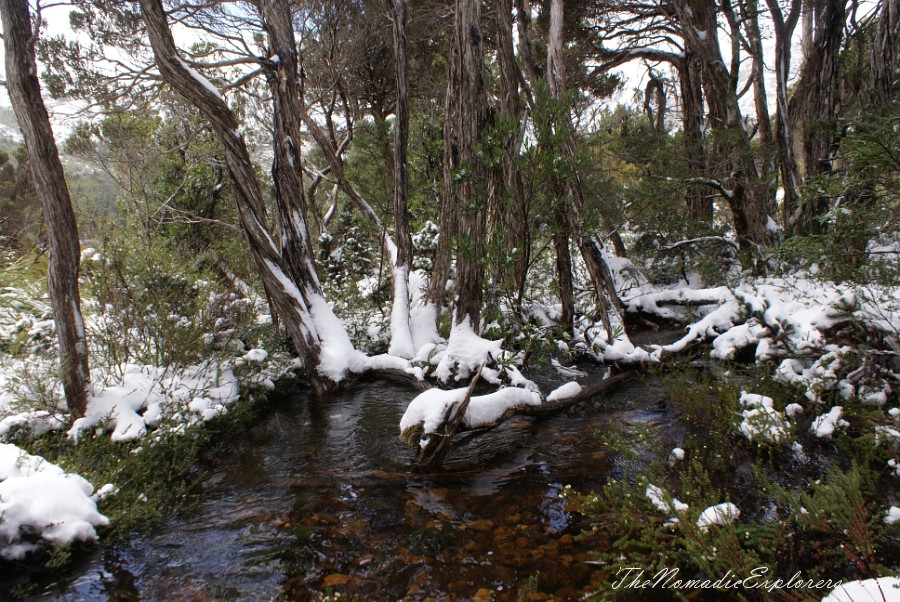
left=0, top=0, right=90, bottom=418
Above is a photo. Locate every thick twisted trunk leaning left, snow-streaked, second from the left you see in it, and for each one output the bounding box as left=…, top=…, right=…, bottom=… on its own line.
left=140, top=0, right=336, bottom=393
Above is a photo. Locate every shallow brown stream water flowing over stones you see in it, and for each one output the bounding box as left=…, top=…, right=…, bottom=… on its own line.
left=29, top=360, right=674, bottom=601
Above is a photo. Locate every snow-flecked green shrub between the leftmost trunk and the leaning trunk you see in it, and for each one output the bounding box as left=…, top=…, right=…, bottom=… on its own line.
left=82, top=229, right=260, bottom=368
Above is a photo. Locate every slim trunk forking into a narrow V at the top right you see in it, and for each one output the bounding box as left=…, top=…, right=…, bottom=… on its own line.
left=766, top=0, right=803, bottom=233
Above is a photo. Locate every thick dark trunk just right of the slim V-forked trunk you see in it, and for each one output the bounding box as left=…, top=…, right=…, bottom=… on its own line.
left=789, top=0, right=847, bottom=233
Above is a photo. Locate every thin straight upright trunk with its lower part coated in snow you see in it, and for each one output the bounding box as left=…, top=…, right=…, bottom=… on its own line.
left=389, top=0, right=416, bottom=358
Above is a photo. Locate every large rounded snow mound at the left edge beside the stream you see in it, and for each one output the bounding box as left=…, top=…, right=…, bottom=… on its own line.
left=0, top=443, right=109, bottom=560
